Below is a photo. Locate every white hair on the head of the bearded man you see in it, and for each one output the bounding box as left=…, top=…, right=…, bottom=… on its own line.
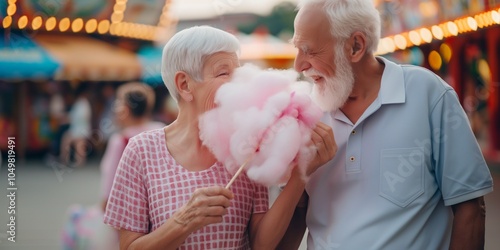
left=297, top=0, right=381, bottom=53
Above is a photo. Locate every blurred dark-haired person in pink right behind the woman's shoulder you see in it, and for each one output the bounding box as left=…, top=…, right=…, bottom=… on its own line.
left=62, top=82, right=165, bottom=250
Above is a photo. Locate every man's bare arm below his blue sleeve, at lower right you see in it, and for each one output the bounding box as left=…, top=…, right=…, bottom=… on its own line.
left=450, top=197, right=486, bottom=250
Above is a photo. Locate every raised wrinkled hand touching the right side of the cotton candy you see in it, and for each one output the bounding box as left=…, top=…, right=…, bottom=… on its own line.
left=306, top=122, right=337, bottom=176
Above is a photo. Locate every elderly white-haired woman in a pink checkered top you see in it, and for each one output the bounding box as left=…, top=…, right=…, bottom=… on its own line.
left=104, top=26, right=334, bottom=249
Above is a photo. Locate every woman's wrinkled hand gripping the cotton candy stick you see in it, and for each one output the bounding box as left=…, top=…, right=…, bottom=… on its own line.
left=172, top=186, right=234, bottom=230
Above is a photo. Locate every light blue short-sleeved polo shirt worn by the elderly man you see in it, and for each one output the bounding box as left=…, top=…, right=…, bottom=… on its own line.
left=306, top=58, right=493, bottom=250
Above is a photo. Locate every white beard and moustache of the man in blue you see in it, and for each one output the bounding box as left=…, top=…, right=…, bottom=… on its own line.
left=304, top=46, right=354, bottom=112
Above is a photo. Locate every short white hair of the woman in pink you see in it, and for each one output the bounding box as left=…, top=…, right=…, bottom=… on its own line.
left=161, top=26, right=240, bottom=102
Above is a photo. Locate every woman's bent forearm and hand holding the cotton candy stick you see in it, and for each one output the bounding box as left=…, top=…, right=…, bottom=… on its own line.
left=120, top=186, right=233, bottom=250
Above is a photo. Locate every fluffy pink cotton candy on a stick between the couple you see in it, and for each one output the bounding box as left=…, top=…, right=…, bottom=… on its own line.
left=199, top=64, right=322, bottom=185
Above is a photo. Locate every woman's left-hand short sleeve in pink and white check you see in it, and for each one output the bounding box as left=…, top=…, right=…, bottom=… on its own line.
left=104, top=138, right=149, bottom=233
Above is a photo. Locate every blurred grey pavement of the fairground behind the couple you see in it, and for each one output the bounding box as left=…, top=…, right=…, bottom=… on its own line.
left=0, top=160, right=500, bottom=250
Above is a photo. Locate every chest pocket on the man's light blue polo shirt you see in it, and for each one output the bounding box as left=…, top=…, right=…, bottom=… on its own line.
left=379, top=147, right=424, bottom=207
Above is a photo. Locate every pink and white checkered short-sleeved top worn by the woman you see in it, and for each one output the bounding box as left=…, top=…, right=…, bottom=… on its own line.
left=104, top=129, right=269, bottom=250
